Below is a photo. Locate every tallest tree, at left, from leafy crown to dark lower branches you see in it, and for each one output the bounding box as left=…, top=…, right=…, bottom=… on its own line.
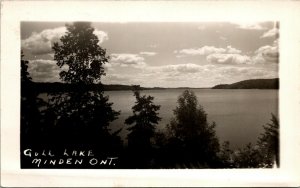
left=46, top=22, right=119, bottom=149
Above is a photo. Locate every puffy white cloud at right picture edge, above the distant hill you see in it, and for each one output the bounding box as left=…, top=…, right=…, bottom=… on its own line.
left=252, top=45, right=279, bottom=64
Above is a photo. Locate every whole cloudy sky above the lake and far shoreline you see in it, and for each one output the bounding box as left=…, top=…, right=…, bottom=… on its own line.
left=21, top=21, right=279, bottom=88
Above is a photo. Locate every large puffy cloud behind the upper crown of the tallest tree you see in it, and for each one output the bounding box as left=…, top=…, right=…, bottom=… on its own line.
left=21, top=27, right=108, bottom=55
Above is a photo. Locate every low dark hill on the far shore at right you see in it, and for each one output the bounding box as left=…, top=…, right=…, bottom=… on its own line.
left=212, top=78, right=279, bottom=89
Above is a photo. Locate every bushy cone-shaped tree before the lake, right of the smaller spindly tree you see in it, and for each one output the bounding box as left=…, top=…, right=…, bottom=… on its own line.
left=167, top=90, right=219, bottom=167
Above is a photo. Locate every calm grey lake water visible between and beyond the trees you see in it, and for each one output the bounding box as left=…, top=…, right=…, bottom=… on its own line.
left=105, top=89, right=278, bottom=149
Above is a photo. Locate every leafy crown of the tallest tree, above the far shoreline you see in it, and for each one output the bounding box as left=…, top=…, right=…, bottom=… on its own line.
left=53, top=22, right=108, bottom=84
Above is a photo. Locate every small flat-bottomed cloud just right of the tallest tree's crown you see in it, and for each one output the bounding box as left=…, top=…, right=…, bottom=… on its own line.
left=111, top=53, right=146, bottom=68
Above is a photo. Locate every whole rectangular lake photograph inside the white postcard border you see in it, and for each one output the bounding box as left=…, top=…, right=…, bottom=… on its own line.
left=20, top=20, right=280, bottom=169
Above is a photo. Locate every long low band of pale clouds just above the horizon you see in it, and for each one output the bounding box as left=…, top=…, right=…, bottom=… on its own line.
left=102, top=59, right=278, bottom=87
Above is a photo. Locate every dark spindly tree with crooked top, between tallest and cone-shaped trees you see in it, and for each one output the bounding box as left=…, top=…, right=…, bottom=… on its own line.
left=125, top=86, right=161, bottom=168
